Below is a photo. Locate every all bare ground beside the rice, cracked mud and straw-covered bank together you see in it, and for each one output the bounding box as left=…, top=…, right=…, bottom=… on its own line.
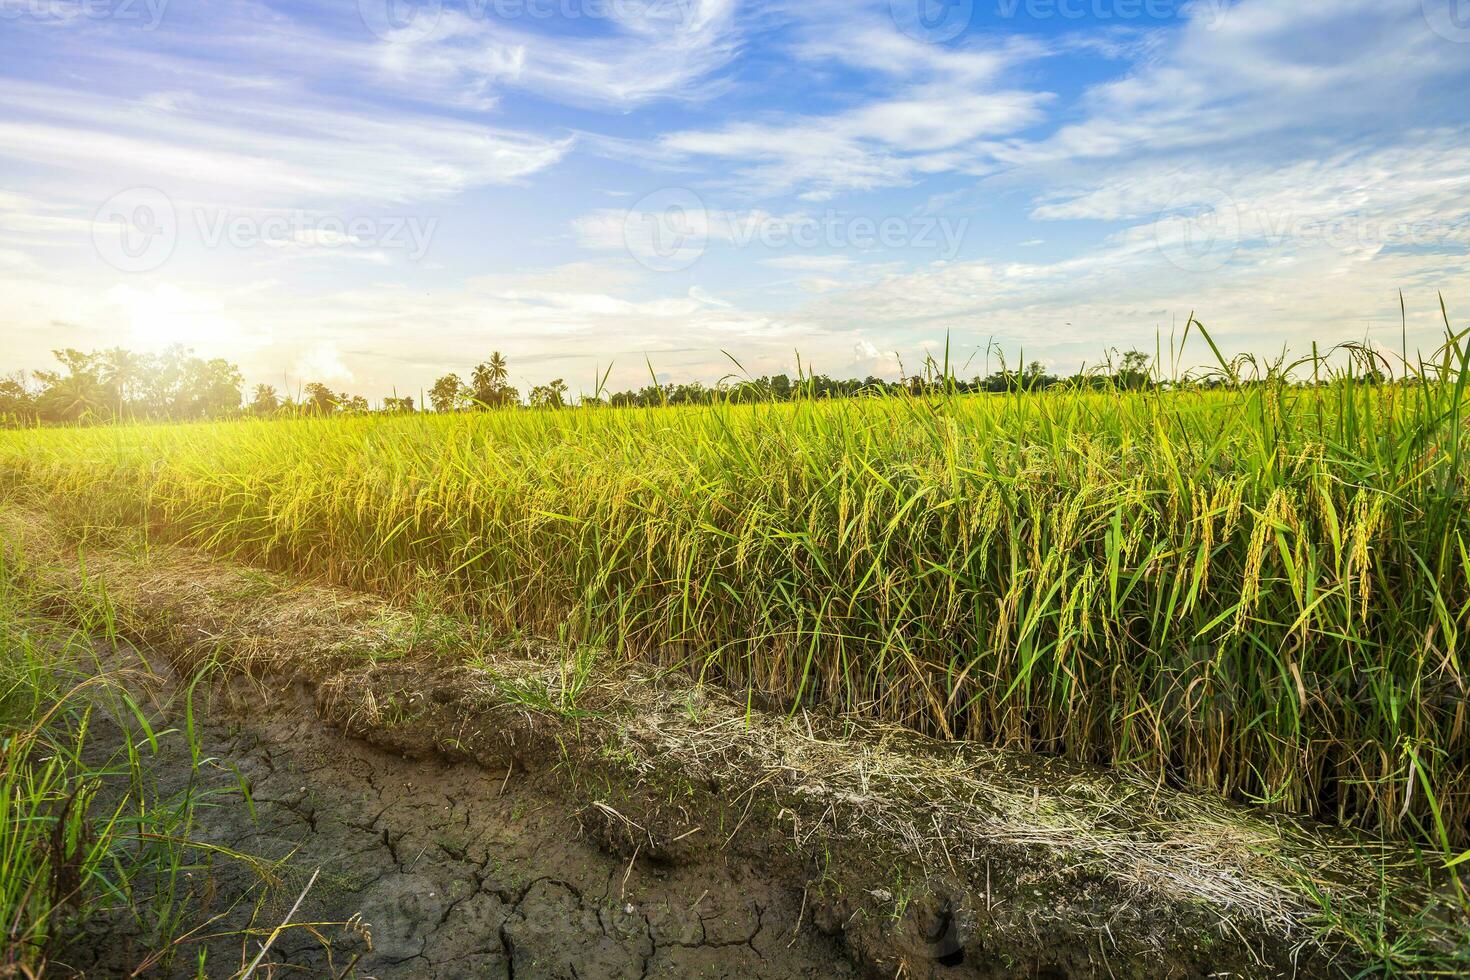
left=20, top=508, right=1463, bottom=980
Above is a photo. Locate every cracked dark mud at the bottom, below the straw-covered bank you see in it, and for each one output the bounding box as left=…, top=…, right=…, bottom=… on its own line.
left=65, top=681, right=851, bottom=980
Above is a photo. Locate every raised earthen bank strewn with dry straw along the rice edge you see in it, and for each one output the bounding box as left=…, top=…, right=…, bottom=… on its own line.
left=0, top=505, right=1454, bottom=976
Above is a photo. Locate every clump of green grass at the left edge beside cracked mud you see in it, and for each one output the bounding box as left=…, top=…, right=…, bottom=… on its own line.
left=0, top=552, right=255, bottom=976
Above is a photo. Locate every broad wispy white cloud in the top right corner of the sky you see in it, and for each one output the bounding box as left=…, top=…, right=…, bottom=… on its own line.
left=988, top=0, right=1466, bottom=167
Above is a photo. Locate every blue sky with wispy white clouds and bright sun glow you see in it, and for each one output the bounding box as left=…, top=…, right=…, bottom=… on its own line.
left=0, top=0, right=1470, bottom=398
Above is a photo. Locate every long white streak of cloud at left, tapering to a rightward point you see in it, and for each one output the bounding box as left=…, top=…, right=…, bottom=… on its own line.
left=0, top=82, right=570, bottom=206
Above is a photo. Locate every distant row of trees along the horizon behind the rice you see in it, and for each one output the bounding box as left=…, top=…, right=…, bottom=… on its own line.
left=0, top=345, right=1170, bottom=426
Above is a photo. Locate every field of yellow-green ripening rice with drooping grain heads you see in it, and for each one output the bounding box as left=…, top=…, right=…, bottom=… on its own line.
left=0, top=335, right=1470, bottom=851
